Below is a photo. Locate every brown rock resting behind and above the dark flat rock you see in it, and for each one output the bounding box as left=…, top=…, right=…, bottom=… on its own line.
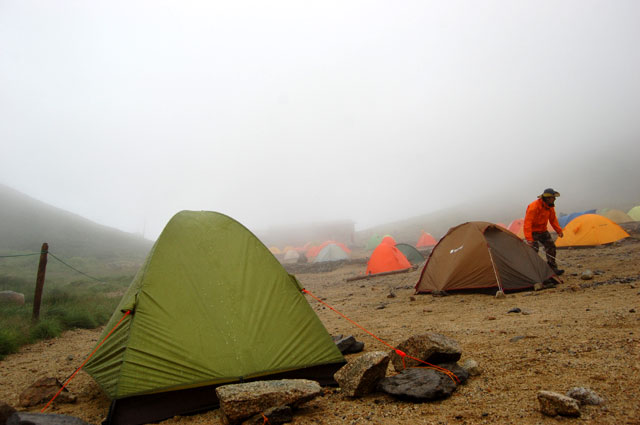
left=391, top=333, right=462, bottom=372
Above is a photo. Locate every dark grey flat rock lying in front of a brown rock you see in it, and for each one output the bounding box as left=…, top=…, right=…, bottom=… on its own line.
left=378, top=368, right=457, bottom=401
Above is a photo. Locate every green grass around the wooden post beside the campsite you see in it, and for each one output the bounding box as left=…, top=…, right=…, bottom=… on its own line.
left=0, top=276, right=132, bottom=360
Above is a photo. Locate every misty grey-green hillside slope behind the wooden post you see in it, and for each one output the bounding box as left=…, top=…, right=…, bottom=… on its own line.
left=0, top=184, right=153, bottom=276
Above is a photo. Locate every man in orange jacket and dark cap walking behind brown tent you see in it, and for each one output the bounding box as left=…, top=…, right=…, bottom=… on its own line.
left=524, top=188, right=564, bottom=276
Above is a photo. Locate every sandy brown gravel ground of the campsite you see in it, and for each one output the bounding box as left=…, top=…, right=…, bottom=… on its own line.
left=0, top=234, right=640, bottom=425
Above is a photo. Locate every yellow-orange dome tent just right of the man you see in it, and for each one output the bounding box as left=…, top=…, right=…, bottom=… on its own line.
left=556, top=214, right=629, bottom=248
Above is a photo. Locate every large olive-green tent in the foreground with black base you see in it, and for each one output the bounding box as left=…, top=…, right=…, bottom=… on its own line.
left=85, top=211, right=344, bottom=424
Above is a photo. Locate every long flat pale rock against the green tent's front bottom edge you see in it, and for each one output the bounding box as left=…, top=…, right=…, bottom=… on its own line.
left=216, top=379, right=322, bottom=424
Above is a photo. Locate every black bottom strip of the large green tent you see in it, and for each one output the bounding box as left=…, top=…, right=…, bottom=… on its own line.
left=103, top=362, right=345, bottom=425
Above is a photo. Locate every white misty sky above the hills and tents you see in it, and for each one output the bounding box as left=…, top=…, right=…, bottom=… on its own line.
left=0, top=0, right=640, bottom=238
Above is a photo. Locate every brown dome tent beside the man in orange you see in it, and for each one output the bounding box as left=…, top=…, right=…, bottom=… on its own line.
left=416, top=221, right=554, bottom=293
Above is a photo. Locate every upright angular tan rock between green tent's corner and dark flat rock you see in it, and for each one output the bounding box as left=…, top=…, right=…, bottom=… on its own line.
left=333, top=351, right=389, bottom=397
